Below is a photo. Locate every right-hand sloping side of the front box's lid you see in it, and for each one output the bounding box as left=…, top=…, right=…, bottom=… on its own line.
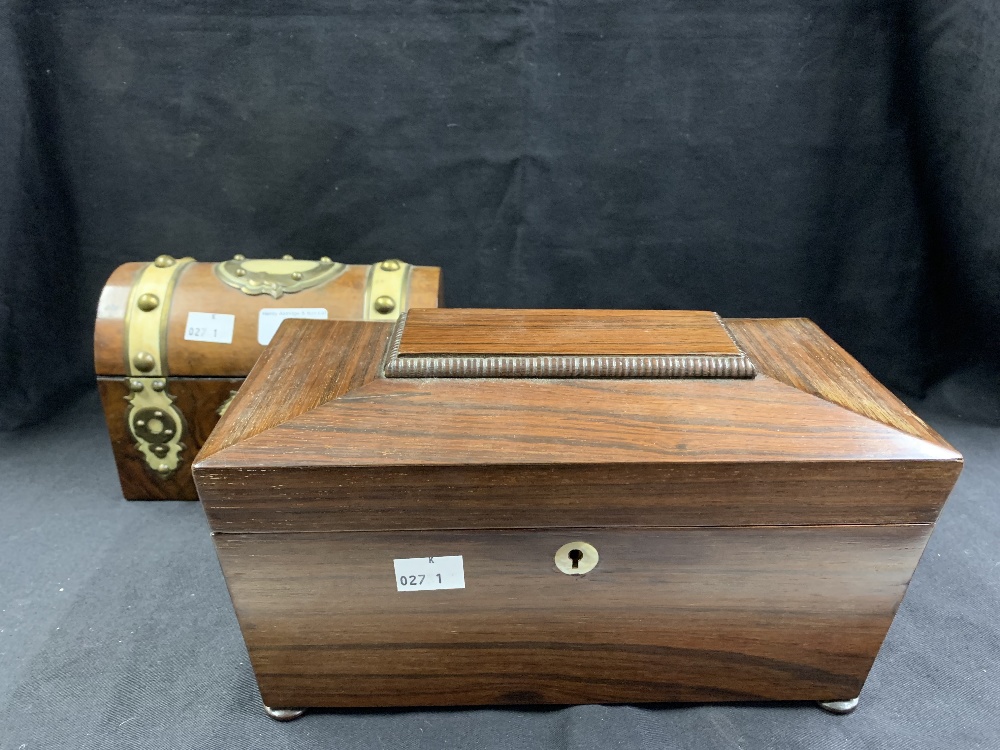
left=726, top=318, right=951, bottom=448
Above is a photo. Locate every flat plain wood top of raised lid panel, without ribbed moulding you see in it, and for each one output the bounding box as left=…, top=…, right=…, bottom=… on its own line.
left=399, top=312, right=740, bottom=357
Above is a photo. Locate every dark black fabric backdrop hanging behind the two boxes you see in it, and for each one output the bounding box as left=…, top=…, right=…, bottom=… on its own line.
left=0, top=0, right=1000, bottom=428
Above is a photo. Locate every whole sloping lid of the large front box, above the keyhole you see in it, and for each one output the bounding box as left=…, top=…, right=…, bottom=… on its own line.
left=194, top=310, right=961, bottom=532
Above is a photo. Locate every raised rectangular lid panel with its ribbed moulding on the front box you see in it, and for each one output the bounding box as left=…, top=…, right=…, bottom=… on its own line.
left=385, top=309, right=754, bottom=378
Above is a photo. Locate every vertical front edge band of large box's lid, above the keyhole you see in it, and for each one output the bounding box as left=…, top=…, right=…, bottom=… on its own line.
left=196, top=461, right=959, bottom=533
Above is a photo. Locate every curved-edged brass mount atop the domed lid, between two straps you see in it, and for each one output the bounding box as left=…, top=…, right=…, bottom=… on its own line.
left=213, top=255, right=347, bottom=299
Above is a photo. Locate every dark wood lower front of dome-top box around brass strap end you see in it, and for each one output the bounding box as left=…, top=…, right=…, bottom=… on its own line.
left=97, top=377, right=243, bottom=500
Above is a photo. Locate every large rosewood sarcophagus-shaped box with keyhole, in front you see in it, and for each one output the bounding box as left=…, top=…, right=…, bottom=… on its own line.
left=194, top=310, right=962, bottom=716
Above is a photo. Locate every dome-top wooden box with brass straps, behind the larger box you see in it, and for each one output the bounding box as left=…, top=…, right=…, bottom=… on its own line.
left=94, top=255, right=441, bottom=500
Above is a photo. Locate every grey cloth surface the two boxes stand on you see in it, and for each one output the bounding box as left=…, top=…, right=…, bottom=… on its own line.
left=0, top=397, right=1000, bottom=750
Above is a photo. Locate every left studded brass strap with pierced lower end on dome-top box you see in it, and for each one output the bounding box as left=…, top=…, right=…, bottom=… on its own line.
left=125, top=255, right=194, bottom=479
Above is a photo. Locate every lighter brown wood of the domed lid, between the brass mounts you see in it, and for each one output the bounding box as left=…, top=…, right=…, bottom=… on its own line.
left=94, top=263, right=441, bottom=377
